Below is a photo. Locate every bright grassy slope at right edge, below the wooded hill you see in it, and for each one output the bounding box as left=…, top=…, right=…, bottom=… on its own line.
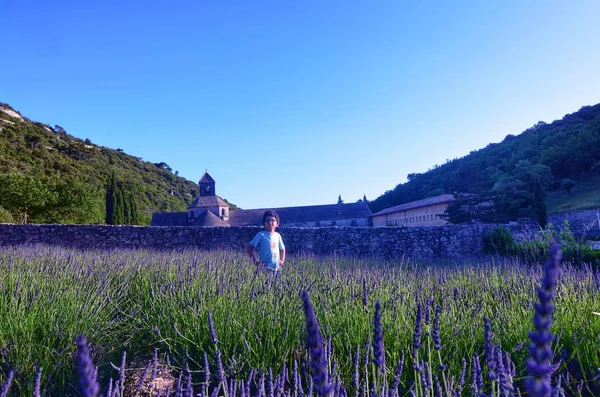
left=546, top=174, right=600, bottom=214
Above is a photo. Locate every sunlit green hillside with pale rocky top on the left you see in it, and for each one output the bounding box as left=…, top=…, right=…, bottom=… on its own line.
left=0, top=103, right=236, bottom=225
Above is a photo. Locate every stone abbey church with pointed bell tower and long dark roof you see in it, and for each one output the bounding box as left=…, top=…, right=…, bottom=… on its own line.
left=151, top=172, right=373, bottom=227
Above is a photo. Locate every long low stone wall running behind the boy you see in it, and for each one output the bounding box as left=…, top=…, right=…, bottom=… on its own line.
left=0, top=224, right=514, bottom=259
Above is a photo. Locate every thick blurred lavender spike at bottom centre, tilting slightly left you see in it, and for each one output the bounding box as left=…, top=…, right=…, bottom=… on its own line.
left=301, top=291, right=332, bottom=396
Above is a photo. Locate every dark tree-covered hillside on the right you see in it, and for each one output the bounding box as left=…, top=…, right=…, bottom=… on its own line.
left=370, top=104, right=600, bottom=223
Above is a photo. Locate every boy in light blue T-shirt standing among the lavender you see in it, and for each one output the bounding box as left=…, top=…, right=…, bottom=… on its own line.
left=246, top=210, right=285, bottom=272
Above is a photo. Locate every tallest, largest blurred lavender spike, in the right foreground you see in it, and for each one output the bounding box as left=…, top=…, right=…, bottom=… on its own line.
left=525, top=245, right=562, bottom=397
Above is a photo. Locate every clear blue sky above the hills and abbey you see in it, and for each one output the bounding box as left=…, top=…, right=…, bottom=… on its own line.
left=0, top=0, right=600, bottom=209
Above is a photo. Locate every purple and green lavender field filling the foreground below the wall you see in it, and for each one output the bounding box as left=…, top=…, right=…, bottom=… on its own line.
left=0, top=246, right=600, bottom=397
